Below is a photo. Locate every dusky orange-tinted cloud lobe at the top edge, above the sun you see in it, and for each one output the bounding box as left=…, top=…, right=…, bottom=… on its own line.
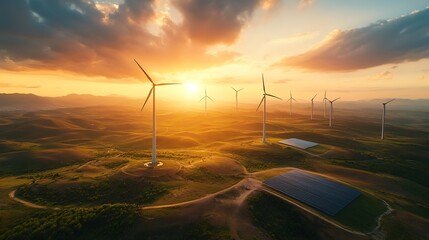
left=173, top=0, right=260, bottom=44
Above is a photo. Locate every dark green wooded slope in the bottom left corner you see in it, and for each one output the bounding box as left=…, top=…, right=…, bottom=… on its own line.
left=0, top=204, right=140, bottom=240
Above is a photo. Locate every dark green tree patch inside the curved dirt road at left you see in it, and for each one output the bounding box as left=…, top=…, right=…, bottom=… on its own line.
left=16, top=178, right=167, bottom=205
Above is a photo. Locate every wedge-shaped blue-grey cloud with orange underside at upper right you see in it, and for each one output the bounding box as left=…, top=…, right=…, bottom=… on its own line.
left=274, top=8, right=429, bottom=71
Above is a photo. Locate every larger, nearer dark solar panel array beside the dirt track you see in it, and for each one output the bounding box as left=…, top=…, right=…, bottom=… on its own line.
left=264, top=170, right=361, bottom=216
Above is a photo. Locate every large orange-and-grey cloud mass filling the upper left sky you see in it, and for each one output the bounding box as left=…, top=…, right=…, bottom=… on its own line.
left=0, top=0, right=259, bottom=78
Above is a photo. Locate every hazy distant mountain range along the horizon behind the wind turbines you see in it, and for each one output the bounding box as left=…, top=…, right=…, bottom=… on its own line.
left=0, top=93, right=429, bottom=112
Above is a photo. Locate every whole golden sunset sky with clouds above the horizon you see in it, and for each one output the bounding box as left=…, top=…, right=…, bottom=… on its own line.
left=0, top=0, right=429, bottom=103
